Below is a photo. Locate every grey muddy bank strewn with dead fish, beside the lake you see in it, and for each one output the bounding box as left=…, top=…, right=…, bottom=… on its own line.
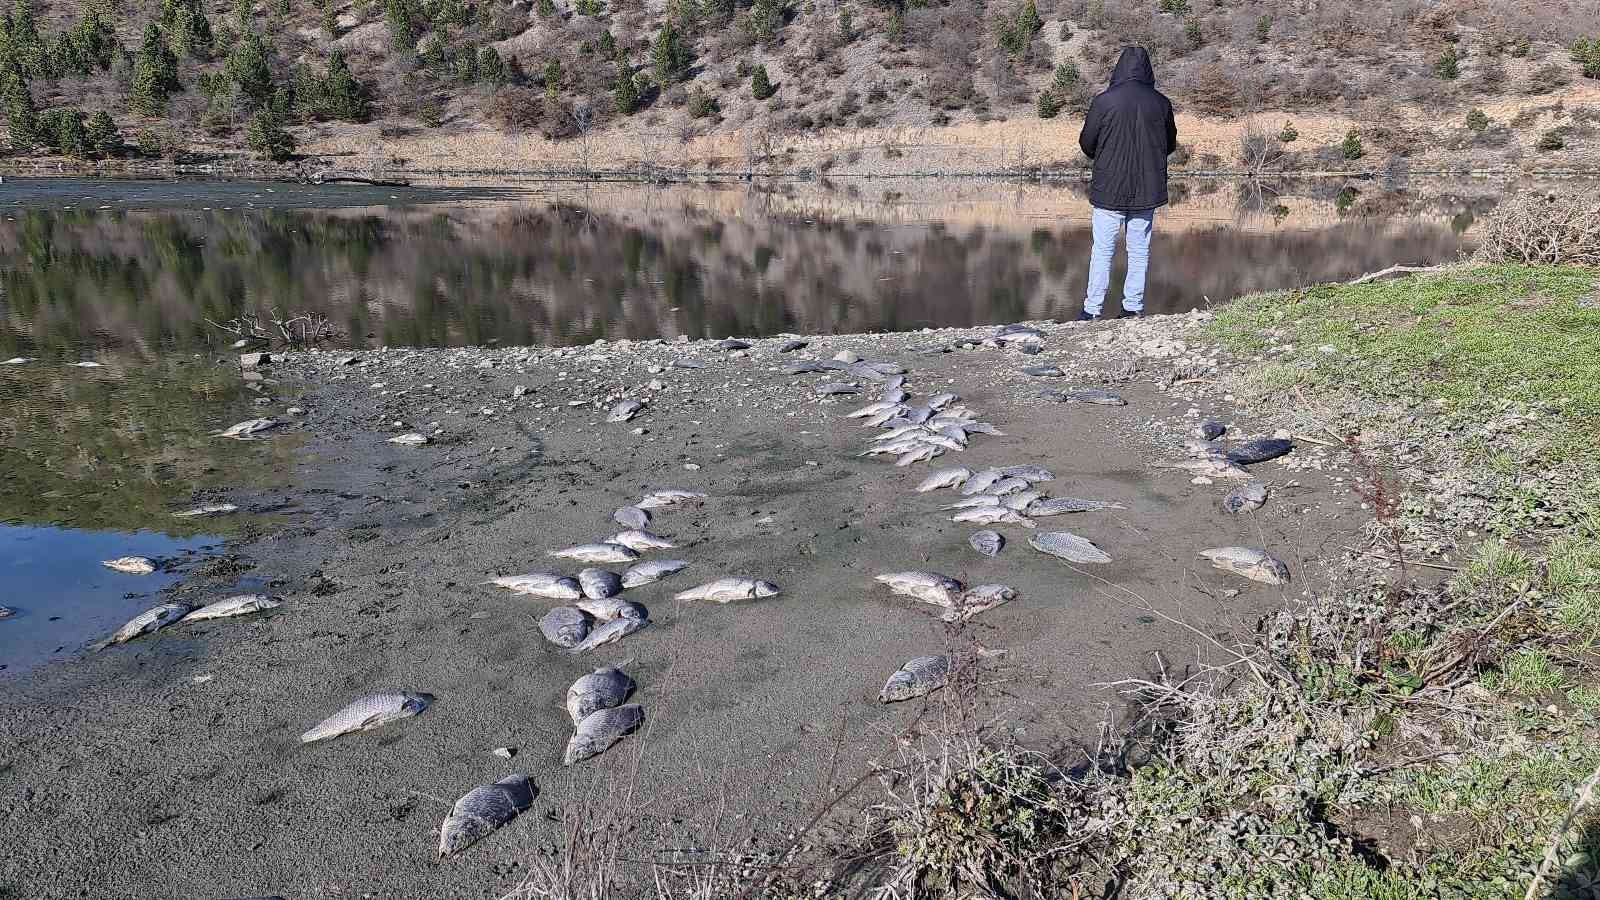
left=0, top=314, right=1362, bottom=898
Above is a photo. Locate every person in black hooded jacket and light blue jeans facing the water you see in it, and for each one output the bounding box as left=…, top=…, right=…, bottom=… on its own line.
left=1078, top=46, right=1178, bottom=320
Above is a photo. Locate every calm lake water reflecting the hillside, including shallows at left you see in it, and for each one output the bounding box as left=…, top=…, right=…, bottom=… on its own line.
left=0, top=173, right=1504, bottom=674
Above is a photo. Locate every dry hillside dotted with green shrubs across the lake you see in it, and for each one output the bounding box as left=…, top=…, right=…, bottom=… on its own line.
left=0, top=0, right=1600, bottom=173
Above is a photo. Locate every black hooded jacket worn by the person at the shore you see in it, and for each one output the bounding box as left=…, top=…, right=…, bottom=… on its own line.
left=1078, top=46, right=1178, bottom=211
